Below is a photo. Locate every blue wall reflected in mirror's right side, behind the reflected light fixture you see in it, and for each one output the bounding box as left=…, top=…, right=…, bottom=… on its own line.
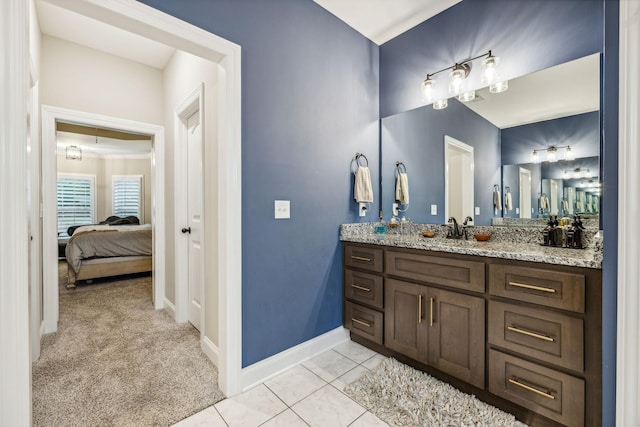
left=501, top=111, right=600, bottom=165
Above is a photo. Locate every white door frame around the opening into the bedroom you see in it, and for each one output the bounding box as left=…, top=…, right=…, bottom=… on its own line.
left=41, top=105, right=165, bottom=333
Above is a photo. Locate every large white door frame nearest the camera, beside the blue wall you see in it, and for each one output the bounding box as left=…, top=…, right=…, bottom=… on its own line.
left=43, top=0, right=242, bottom=396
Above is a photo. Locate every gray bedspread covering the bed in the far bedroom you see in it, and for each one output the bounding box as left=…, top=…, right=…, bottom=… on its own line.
left=65, top=229, right=153, bottom=273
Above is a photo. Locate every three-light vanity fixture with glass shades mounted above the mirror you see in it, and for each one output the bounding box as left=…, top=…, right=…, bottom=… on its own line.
left=422, top=51, right=509, bottom=110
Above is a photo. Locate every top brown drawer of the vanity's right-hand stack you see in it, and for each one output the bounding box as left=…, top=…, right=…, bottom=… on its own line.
left=489, top=264, right=585, bottom=313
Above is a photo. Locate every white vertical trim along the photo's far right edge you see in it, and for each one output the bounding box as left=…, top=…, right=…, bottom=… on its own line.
left=616, top=0, right=640, bottom=426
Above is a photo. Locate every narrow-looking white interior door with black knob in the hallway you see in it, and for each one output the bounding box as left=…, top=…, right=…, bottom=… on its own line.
left=187, top=111, right=204, bottom=330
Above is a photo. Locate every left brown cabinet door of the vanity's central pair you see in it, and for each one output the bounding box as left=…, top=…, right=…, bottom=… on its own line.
left=384, top=279, right=429, bottom=363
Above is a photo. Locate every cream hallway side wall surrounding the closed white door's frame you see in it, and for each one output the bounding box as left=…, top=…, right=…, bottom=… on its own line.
left=164, top=51, right=219, bottom=346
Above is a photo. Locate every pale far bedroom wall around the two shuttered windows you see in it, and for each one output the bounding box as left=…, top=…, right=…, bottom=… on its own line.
left=58, top=154, right=151, bottom=224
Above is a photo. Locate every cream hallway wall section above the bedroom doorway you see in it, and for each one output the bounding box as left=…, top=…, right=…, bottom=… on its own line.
left=40, top=35, right=164, bottom=125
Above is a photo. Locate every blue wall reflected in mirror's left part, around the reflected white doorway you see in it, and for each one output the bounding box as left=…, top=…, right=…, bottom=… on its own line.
left=381, top=99, right=500, bottom=225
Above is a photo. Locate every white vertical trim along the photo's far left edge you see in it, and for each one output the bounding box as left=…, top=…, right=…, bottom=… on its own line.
left=0, top=1, right=31, bottom=426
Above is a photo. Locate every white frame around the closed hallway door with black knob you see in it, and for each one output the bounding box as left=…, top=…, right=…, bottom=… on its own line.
left=174, top=83, right=204, bottom=332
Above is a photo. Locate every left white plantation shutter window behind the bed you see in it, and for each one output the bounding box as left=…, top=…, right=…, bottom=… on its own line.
left=57, top=174, right=96, bottom=235
